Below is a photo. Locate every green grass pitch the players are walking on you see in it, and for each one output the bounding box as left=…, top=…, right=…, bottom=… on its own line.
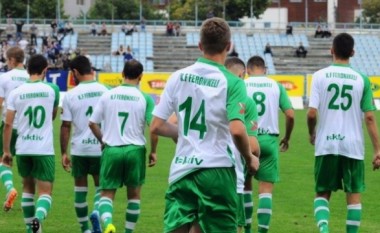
left=0, top=111, right=380, bottom=233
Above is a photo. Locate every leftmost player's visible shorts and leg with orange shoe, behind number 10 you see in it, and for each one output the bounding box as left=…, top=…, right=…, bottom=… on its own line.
left=0, top=127, right=17, bottom=211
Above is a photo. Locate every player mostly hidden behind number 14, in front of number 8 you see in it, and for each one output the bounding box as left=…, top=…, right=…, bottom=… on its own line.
left=224, top=57, right=260, bottom=232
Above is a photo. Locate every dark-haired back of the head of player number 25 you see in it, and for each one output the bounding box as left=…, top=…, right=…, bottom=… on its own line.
left=333, top=33, right=355, bottom=60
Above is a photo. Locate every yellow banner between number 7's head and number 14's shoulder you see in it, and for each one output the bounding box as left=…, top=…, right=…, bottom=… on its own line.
left=140, top=73, right=171, bottom=95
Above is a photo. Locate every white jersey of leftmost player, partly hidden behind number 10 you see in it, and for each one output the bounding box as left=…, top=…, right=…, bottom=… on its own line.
left=0, top=68, right=29, bottom=128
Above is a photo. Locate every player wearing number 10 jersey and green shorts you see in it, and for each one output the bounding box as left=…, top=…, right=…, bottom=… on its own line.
left=3, top=55, right=59, bottom=233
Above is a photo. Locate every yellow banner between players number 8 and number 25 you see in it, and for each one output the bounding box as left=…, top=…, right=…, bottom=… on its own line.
left=268, top=75, right=305, bottom=97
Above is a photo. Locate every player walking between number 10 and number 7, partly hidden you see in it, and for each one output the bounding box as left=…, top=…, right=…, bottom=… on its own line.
left=61, top=56, right=108, bottom=233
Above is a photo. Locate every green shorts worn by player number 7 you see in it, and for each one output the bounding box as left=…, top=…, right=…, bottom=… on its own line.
left=100, top=145, right=146, bottom=189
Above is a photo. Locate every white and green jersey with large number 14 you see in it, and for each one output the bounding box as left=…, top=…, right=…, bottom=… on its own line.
left=153, top=58, right=247, bottom=184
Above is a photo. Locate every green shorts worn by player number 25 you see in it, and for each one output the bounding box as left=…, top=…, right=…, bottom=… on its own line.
left=314, top=155, right=365, bottom=193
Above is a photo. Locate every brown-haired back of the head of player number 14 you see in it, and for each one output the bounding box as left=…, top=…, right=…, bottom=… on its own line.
left=200, top=17, right=231, bottom=55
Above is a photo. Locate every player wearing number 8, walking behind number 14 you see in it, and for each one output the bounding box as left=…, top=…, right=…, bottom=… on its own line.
left=245, top=56, right=294, bottom=233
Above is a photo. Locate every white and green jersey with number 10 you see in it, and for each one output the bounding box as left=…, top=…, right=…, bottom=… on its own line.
left=7, top=81, right=59, bottom=155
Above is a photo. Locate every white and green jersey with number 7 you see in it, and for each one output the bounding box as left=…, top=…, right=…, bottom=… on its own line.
left=90, top=84, right=154, bottom=146
